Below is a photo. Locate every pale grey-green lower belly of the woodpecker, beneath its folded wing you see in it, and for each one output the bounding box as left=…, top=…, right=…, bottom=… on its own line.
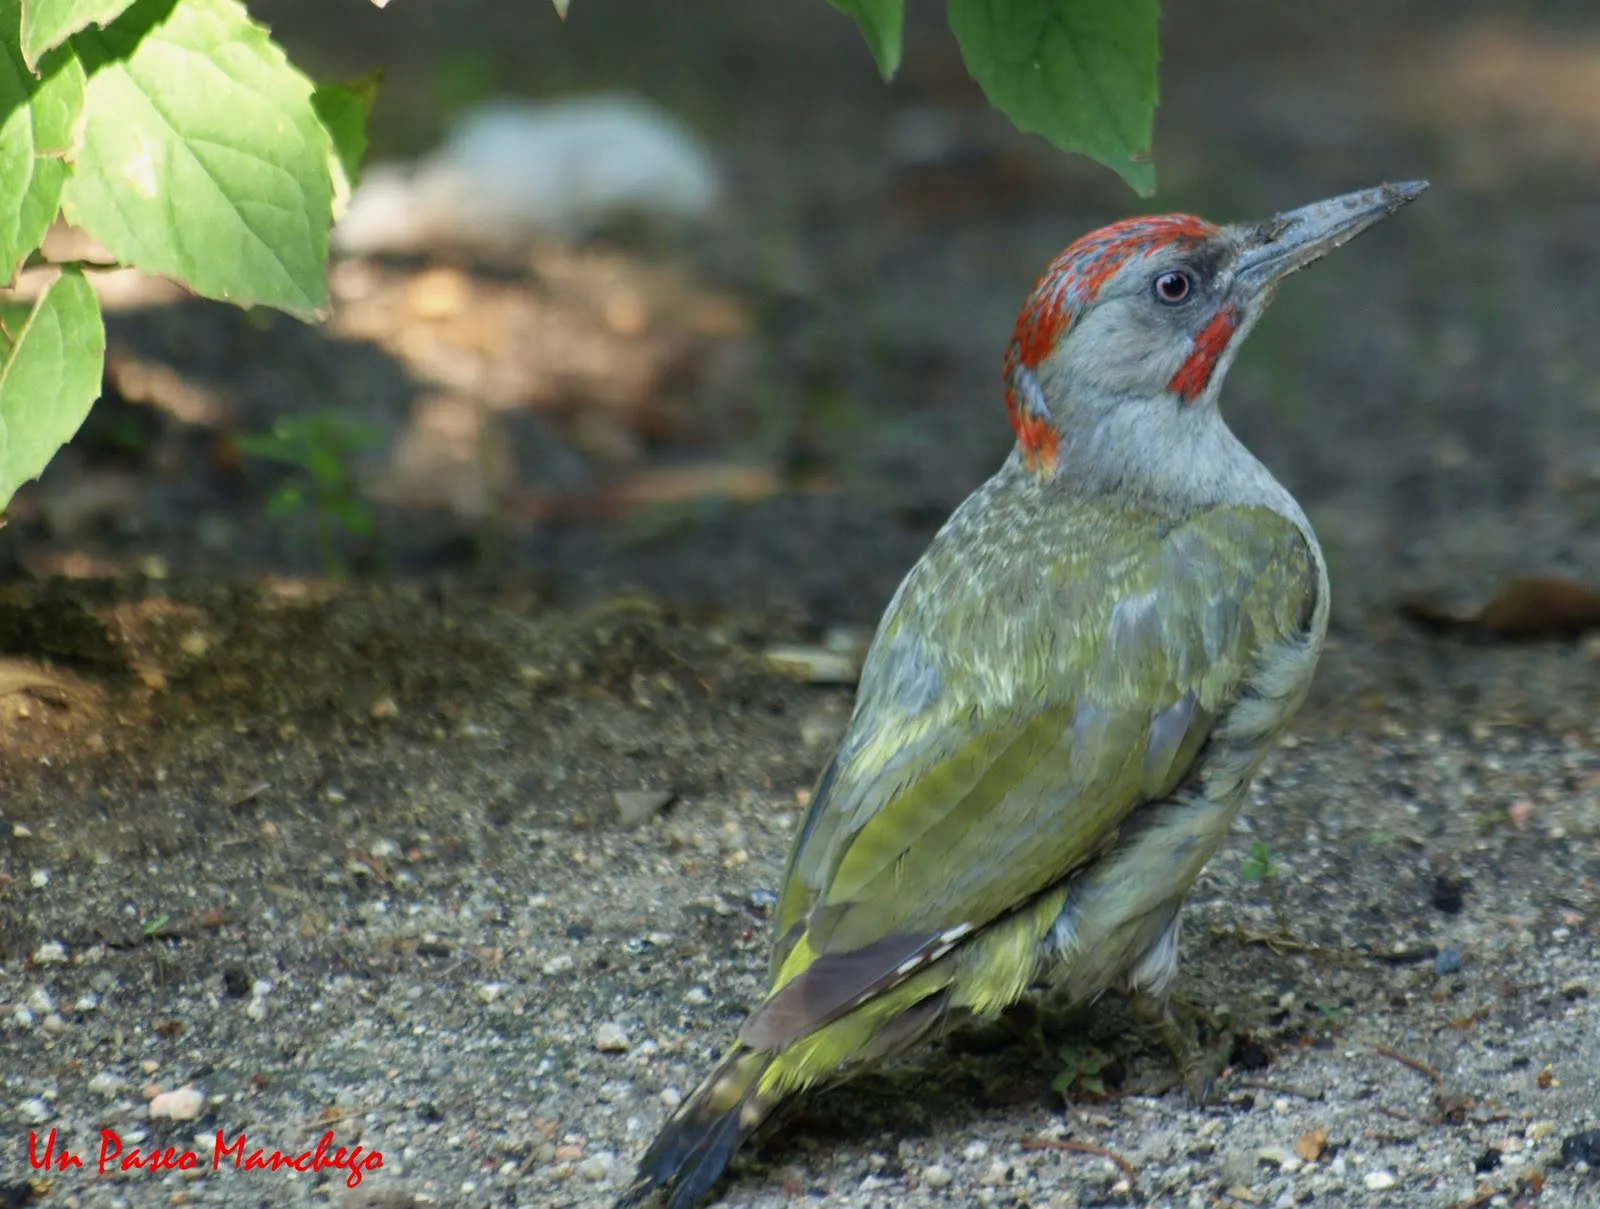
left=1040, top=792, right=1245, bottom=1001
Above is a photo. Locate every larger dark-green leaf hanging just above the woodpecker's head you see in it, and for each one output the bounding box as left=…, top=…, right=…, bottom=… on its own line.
left=949, top=0, right=1158, bottom=197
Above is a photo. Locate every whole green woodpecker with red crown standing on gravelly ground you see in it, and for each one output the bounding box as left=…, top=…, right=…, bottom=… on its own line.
left=619, top=181, right=1427, bottom=1209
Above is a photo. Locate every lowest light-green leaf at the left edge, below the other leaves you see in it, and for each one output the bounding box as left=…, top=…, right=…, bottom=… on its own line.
left=0, top=269, right=106, bottom=509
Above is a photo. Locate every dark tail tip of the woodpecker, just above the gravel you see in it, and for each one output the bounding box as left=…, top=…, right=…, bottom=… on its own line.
left=616, top=1046, right=776, bottom=1209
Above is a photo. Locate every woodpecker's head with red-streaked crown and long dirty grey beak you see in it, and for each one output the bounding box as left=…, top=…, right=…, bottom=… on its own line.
left=1005, top=181, right=1427, bottom=473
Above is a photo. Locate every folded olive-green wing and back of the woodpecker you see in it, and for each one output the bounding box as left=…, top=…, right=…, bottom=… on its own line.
left=744, top=507, right=1317, bottom=1041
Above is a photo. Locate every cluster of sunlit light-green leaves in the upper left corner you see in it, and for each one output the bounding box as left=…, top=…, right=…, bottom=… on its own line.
left=0, top=0, right=373, bottom=510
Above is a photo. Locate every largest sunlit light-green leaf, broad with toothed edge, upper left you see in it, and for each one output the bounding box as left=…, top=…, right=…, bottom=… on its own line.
left=61, top=0, right=333, bottom=318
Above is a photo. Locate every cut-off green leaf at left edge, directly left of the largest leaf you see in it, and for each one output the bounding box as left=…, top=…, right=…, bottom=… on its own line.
left=0, top=13, right=83, bottom=281
